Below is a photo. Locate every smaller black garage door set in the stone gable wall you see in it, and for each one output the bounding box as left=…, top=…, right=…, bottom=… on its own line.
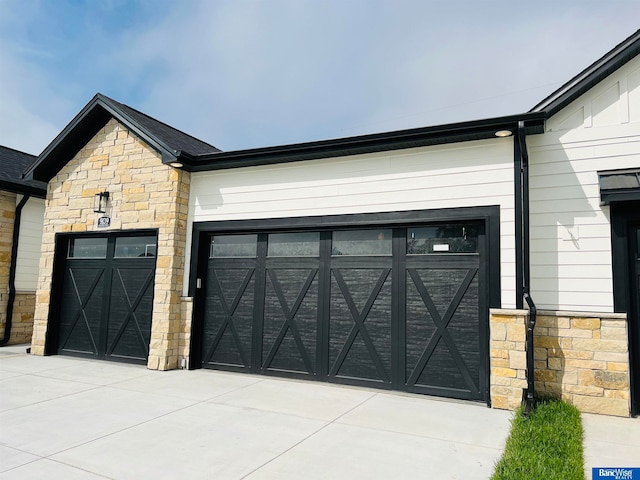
left=54, top=234, right=156, bottom=363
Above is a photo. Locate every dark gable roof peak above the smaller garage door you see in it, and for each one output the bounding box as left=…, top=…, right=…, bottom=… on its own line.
left=25, top=93, right=220, bottom=182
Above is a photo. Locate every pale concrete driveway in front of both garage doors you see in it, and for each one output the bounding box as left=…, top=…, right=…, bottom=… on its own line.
left=0, top=346, right=512, bottom=480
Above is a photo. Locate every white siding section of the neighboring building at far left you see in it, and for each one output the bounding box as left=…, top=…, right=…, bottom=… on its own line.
left=15, top=198, right=44, bottom=292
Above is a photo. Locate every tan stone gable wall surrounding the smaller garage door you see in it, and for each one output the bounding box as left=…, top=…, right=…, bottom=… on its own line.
left=31, top=119, right=190, bottom=370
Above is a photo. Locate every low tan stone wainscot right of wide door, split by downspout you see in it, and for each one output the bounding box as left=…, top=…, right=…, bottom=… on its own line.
left=490, top=309, right=631, bottom=417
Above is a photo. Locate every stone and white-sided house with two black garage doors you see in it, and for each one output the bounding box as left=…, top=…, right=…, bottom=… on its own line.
left=18, top=31, right=640, bottom=416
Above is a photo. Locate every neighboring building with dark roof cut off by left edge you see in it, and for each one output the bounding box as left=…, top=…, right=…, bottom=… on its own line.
left=0, top=146, right=47, bottom=345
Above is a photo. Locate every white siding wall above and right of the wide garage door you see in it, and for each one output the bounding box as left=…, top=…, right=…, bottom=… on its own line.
left=185, top=138, right=515, bottom=308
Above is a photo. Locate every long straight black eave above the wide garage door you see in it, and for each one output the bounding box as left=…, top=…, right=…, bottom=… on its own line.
left=182, top=113, right=545, bottom=172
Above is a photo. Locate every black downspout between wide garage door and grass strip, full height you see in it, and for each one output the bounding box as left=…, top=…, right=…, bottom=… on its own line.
left=516, top=121, right=538, bottom=417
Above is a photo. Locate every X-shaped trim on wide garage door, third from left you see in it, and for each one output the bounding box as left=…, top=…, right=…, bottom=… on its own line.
left=329, top=268, right=391, bottom=382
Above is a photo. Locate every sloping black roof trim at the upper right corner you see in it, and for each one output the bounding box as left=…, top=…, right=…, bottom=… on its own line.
left=530, top=30, right=640, bottom=118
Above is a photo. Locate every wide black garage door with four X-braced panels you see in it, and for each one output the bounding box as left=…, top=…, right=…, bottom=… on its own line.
left=196, top=222, right=487, bottom=400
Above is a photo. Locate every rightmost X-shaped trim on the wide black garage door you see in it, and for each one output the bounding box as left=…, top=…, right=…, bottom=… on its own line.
left=407, top=268, right=478, bottom=392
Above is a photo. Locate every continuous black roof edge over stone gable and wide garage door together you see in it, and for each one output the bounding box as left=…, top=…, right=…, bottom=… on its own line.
left=25, top=93, right=545, bottom=181
